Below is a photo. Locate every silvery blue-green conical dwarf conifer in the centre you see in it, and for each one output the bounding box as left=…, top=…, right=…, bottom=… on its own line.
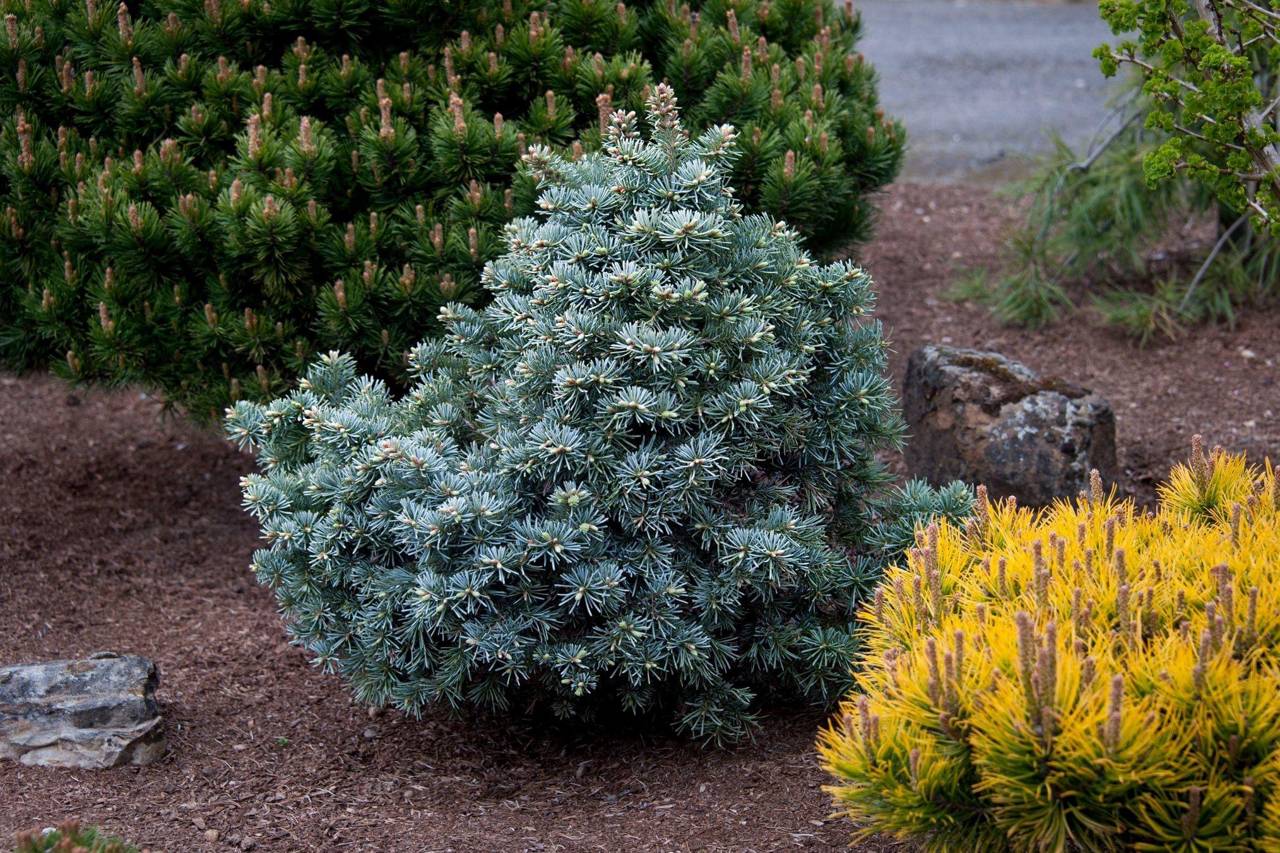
left=228, top=86, right=969, bottom=742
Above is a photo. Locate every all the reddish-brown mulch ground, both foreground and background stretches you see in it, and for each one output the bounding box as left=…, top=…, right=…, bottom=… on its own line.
left=0, top=184, right=1280, bottom=850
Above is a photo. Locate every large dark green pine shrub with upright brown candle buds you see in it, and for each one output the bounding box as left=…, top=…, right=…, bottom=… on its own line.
left=0, top=0, right=904, bottom=419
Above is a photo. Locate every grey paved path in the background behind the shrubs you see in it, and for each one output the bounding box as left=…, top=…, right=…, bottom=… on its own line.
left=858, top=0, right=1110, bottom=179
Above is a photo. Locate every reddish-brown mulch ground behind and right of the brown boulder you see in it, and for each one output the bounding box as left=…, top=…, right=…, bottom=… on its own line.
left=863, top=184, right=1280, bottom=502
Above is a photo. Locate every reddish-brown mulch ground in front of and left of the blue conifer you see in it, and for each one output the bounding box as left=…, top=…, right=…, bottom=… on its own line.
left=0, top=377, right=884, bottom=852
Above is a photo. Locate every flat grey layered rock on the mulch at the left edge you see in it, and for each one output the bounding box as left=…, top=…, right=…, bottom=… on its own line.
left=0, top=652, right=165, bottom=768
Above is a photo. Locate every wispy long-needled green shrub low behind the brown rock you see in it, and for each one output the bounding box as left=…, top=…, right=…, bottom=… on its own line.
left=952, top=93, right=1280, bottom=343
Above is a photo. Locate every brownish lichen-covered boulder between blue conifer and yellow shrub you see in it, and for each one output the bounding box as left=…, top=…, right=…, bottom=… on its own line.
left=902, top=346, right=1116, bottom=506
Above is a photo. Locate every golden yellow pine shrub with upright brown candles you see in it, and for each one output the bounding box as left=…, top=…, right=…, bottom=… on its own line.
left=818, top=437, right=1280, bottom=852
